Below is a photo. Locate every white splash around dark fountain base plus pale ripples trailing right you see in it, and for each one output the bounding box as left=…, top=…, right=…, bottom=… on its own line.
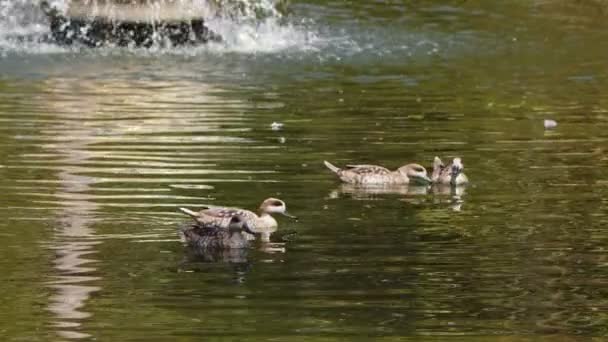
left=0, top=0, right=456, bottom=68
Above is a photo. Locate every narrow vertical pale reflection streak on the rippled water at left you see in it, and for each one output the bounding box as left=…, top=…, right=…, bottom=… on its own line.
left=48, top=121, right=101, bottom=339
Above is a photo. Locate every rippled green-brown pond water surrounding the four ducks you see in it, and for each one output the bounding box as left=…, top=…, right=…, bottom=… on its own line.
left=0, top=0, right=608, bottom=341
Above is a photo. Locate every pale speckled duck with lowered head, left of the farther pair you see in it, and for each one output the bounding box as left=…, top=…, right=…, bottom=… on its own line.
left=324, top=161, right=431, bottom=184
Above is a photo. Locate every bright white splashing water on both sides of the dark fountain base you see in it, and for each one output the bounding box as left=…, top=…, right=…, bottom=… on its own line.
left=0, top=0, right=330, bottom=56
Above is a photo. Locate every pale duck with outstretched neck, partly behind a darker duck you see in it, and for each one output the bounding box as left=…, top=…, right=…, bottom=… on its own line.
left=179, top=197, right=298, bottom=242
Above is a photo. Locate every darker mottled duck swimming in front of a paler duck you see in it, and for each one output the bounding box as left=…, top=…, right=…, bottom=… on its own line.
left=180, top=215, right=254, bottom=249
